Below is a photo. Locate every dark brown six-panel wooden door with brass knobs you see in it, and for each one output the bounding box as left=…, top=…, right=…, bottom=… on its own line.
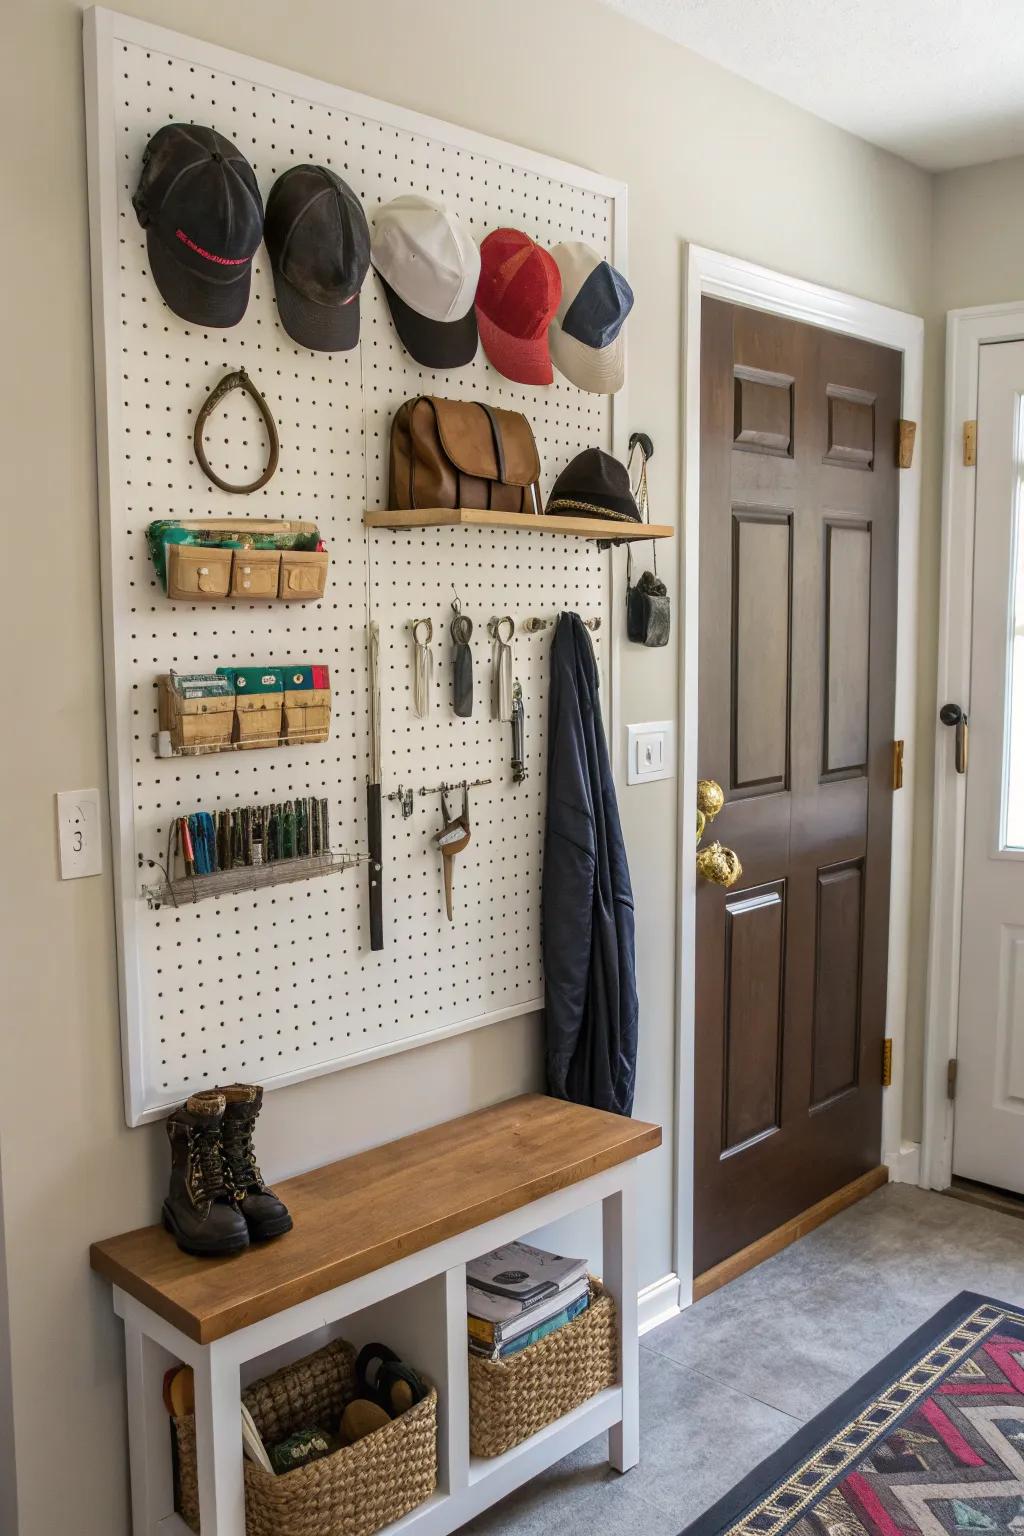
left=694, top=300, right=901, bottom=1273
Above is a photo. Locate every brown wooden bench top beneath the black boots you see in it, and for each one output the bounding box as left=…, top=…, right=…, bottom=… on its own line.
left=89, top=1094, right=662, bottom=1344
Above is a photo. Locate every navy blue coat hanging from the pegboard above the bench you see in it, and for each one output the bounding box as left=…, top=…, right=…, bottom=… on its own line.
left=542, top=613, right=637, bottom=1115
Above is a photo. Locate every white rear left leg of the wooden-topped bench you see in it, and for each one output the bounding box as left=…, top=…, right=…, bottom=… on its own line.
left=124, top=1321, right=177, bottom=1536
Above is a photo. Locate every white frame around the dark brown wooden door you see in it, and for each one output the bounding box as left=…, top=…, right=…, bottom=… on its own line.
left=676, top=244, right=924, bottom=1306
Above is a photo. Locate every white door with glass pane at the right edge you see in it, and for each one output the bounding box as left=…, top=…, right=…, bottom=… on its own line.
left=949, top=341, right=1024, bottom=1193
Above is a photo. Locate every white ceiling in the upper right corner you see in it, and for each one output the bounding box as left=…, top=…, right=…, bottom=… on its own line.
left=605, top=0, right=1024, bottom=170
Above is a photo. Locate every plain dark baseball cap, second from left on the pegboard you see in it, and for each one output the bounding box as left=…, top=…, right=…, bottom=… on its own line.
left=264, top=166, right=370, bottom=352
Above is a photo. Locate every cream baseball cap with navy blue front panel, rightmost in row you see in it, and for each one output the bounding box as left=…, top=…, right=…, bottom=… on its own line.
left=548, top=240, right=633, bottom=395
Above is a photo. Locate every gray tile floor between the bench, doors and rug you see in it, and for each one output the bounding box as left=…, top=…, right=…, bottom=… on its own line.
left=464, top=1184, right=1024, bottom=1536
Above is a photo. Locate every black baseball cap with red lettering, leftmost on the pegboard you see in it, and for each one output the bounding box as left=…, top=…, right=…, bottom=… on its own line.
left=132, top=123, right=263, bottom=326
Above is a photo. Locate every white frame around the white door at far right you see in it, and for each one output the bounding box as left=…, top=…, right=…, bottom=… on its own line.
left=921, top=301, right=1024, bottom=1189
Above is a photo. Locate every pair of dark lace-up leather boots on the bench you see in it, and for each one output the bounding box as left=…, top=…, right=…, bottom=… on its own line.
left=163, top=1083, right=292, bottom=1258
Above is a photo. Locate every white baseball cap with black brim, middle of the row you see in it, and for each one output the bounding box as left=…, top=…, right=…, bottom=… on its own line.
left=370, top=192, right=481, bottom=369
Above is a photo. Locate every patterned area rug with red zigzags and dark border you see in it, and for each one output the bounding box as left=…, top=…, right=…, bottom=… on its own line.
left=685, top=1290, right=1024, bottom=1536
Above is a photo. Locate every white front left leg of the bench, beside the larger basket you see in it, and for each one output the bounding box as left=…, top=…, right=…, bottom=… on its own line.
left=195, top=1339, right=246, bottom=1536
